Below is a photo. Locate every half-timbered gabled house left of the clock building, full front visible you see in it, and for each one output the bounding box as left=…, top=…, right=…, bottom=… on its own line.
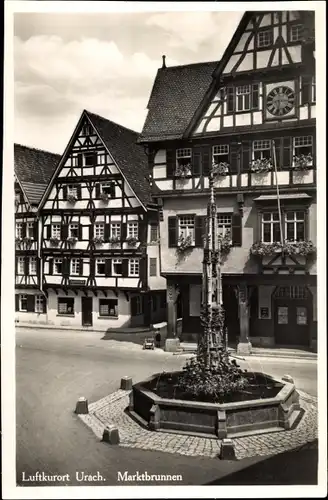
left=39, top=111, right=166, bottom=330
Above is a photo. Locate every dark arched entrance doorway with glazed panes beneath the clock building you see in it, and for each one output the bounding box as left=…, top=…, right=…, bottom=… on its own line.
left=273, top=285, right=313, bottom=346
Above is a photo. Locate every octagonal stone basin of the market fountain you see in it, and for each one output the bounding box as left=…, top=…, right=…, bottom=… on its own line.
left=129, top=372, right=300, bottom=439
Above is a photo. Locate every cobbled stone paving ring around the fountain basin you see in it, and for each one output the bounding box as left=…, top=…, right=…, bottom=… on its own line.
left=79, top=390, right=317, bottom=459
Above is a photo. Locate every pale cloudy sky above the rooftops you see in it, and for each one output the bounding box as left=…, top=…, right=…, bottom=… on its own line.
left=14, top=11, right=242, bottom=153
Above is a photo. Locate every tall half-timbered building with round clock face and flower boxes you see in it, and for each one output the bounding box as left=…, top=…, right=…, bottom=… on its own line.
left=139, top=11, right=317, bottom=352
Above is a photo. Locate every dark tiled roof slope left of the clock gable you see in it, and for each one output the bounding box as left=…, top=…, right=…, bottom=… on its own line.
left=138, top=61, right=218, bottom=143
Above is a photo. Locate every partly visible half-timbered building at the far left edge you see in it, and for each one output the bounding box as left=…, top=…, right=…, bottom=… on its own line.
left=14, top=144, right=60, bottom=323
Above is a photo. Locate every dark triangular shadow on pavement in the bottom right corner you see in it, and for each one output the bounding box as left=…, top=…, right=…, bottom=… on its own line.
left=206, top=440, right=318, bottom=486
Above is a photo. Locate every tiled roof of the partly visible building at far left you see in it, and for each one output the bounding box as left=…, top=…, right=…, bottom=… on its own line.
left=14, top=144, right=60, bottom=205
